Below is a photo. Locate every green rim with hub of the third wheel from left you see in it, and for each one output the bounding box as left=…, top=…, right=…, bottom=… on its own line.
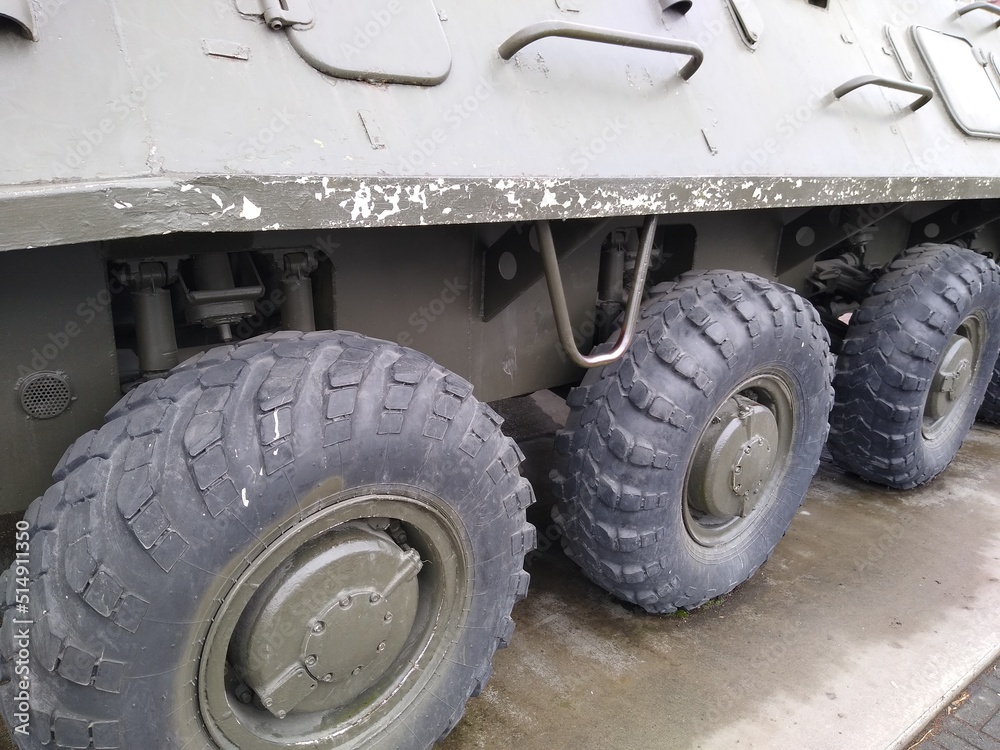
left=922, top=313, right=986, bottom=442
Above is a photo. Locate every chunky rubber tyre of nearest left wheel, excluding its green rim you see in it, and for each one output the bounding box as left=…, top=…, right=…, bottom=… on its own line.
left=0, top=333, right=535, bottom=750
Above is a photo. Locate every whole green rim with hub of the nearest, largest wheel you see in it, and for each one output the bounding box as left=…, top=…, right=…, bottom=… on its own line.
left=198, top=494, right=471, bottom=750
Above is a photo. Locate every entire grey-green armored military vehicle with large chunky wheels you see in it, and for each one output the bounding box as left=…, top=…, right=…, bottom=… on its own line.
left=0, top=0, right=1000, bottom=750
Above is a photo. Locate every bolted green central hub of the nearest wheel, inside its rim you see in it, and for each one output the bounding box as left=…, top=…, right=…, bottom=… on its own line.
left=230, top=523, right=422, bottom=719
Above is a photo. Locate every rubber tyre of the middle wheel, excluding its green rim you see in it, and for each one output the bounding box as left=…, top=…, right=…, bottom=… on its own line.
left=552, top=271, right=833, bottom=612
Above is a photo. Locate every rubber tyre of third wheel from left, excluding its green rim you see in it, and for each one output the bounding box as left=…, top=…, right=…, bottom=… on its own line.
left=830, top=245, right=1000, bottom=489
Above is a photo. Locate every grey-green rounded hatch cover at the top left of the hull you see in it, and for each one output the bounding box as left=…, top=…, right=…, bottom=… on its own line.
left=288, top=0, right=451, bottom=86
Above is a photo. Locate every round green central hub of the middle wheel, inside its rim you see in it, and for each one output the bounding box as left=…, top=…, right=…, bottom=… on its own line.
left=689, top=395, right=779, bottom=518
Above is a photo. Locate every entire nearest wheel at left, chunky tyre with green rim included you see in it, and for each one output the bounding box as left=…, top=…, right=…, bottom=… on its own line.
left=0, top=333, right=534, bottom=750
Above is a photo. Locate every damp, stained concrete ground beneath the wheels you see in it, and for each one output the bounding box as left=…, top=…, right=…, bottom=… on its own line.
left=0, top=393, right=1000, bottom=750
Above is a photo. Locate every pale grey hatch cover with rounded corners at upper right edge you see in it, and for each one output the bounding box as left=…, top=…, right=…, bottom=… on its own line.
left=913, top=26, right=1000, bottom=138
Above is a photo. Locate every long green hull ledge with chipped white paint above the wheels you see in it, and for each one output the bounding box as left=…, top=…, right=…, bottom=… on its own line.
left=0, top=175, right=1000, bottom=250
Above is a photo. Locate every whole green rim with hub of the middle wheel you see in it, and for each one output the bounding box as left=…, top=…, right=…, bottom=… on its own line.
left=683, top=371, right=797, bottom=547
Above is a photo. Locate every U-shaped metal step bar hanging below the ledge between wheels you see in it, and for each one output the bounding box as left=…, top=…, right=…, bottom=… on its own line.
left=537, top=216, right=658, bottom=368
